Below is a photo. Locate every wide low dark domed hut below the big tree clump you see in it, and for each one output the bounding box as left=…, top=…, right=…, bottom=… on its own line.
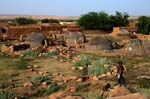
left=87, top=37, right=112, bottom=51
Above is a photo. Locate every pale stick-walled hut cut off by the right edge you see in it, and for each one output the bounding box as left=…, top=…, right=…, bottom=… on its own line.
left=125, top=39, right=150, bottom=56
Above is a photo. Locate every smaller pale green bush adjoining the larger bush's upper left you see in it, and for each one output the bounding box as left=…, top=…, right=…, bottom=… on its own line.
left=74, top=54, right=92, bottom=67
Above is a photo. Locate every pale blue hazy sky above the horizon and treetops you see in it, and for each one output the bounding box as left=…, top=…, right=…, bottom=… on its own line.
left=0, top=0, right=150, bottom=16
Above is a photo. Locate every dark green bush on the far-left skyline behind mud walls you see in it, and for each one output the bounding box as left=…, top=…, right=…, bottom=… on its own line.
left=15, top=17, right=37, bottom=25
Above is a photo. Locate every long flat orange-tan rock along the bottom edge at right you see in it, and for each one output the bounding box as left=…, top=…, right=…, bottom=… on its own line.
left=106, top=93, right=148, bottom=99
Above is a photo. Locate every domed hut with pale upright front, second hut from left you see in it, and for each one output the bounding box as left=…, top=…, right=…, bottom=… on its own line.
left=64, top=32, right=85, bottom=45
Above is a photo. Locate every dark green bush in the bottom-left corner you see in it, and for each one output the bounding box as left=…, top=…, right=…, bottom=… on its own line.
left=0, top=90, right=17, bottom=99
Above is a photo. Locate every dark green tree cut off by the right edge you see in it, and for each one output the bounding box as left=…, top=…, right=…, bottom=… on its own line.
left=137, top=16, right=150, bottom=34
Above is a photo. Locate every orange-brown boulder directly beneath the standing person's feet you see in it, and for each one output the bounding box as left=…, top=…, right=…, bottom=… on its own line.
left=109, top=86, right=131, bottom=97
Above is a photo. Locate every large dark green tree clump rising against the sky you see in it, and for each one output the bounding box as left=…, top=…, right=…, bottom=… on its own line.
left=77, top=11, right=129, bottom=30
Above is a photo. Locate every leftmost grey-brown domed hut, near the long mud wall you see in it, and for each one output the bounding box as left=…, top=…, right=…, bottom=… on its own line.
left=25, top=32, right=47, bottom=48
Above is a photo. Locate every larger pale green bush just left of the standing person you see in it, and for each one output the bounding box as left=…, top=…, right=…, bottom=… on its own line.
left=88, top=58, right=109, bottom=76
